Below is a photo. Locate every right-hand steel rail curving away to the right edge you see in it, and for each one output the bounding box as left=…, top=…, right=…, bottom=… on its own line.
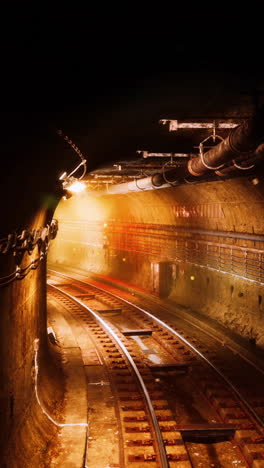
left=50, top=270, right=264, bottom=427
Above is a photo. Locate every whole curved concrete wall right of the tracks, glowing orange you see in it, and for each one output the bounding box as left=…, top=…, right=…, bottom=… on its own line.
left=49, top=178, right=264, bottom=346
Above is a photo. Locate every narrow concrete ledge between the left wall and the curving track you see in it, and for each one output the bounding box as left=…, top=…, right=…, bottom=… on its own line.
left=48, top=300, right=88, bottom=468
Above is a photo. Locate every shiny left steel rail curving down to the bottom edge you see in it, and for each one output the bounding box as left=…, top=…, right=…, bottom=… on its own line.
left=49, top=282, right=170, bottom=468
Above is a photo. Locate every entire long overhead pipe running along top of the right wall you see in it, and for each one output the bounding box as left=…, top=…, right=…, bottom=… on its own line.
left=98, top=112, right=264, bottom=194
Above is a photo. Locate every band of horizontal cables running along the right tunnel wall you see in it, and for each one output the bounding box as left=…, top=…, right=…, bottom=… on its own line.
left=57, top=220, right=264, bottom=284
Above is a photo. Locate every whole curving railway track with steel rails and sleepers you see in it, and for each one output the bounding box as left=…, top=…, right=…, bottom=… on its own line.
left=49, top=271, right=264, bottom=468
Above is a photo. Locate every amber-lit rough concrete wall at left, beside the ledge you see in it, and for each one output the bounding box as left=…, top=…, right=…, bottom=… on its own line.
left=0, top=209, right=64, bottom=468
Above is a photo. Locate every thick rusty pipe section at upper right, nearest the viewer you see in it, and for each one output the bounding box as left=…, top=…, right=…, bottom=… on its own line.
left=187, top=113, right=264, bottom=177
